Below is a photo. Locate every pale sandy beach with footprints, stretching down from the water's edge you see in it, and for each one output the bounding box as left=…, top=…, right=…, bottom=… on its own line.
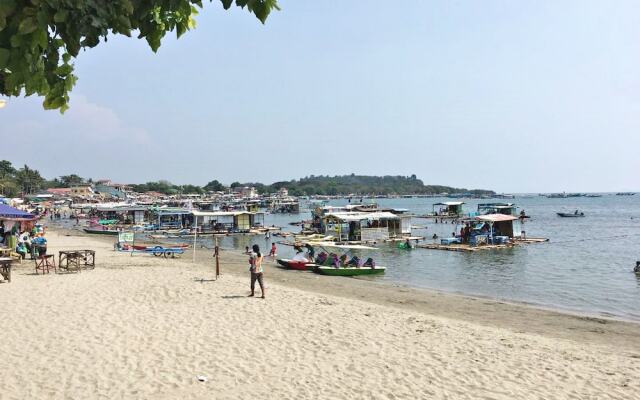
left=0, top=231, right=640, bottom=400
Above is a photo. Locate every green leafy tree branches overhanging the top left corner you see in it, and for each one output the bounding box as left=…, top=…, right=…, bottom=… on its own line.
left=0, top=0, right=278, bottom=112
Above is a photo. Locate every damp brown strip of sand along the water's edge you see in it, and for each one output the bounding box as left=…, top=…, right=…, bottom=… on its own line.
left=53, top=229, right=640, bottom=351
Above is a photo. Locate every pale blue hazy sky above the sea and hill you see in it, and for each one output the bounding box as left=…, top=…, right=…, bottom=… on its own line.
left=0, top=0, right=640, bottom=192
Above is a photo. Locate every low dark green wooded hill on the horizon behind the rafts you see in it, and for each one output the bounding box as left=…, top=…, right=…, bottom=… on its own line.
left=257, top=174, right=495, bottom=196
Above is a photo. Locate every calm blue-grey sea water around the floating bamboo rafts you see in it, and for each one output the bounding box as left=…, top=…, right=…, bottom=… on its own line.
left=221, top=195, right=640, bottom=320
